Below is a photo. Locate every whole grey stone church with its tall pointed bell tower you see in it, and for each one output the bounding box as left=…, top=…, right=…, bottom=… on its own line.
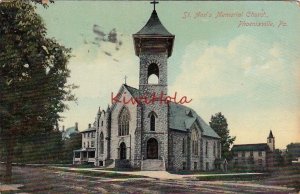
left=81, top=5, right=221, bottom=170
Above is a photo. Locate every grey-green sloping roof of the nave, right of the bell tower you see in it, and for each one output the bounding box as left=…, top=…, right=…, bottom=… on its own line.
left=169, top=102, right=220, bottom=138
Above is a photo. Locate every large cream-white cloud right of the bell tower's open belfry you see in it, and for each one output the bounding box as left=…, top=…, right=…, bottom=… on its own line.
left=171, top=35, right=286, bottom=99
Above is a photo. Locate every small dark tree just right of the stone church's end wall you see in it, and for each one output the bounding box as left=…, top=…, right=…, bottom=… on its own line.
left=209, top=112, right=236, bottom=159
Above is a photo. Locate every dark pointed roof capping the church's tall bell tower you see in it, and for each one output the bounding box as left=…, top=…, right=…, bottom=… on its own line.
left=135, top=10, right=174, bottom=36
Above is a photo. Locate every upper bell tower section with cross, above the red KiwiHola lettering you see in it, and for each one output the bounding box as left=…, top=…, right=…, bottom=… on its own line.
left=133, top=1, right=175, bottom=96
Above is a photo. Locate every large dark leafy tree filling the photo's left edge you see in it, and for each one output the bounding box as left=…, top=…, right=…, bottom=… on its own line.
left=0, top=0, right=76, bottom=182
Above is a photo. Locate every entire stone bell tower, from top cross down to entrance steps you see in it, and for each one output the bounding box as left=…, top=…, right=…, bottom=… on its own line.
left=133, top=0, right=175, bottom=170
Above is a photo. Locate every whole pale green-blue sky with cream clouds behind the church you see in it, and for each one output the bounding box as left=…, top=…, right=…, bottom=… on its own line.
left=38, top=1, right=300, bottom=148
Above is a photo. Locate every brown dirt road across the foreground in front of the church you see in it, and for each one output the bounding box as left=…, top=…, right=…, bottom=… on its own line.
left=1, top=167, right=296, bottom=194
